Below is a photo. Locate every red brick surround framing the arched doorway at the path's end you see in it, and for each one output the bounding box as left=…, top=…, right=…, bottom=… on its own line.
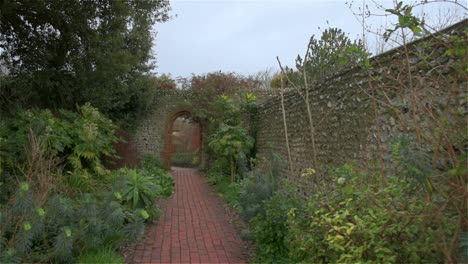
left=161, top=110, right=204, bottom=168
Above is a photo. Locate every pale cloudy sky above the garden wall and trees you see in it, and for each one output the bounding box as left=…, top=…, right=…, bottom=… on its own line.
left=153, top=0, right=467, bottom=77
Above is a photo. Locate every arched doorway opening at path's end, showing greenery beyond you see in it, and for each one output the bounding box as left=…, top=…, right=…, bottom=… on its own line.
left=166, top=112, right=203, bottom=167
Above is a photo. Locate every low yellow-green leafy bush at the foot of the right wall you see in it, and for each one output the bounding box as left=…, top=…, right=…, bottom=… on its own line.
left=240, top=159, right=458, bottom=263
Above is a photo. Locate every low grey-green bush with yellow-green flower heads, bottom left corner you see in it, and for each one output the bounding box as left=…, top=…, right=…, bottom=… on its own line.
left=0, top=182, right=144, bottom=263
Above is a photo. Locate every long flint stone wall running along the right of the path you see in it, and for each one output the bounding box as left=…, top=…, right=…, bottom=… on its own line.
left=257, top=20, right=467, bottom=185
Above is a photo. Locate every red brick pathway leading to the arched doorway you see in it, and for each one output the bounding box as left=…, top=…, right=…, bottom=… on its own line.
left=127, top=167, right=245, bottom=263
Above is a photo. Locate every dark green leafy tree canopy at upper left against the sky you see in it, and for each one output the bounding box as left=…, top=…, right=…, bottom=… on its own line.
left=0, top=0, right=170, bottom=118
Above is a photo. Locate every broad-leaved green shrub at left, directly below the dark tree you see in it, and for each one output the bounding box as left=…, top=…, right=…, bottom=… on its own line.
left=0, top=104, right=117, bottom=197
